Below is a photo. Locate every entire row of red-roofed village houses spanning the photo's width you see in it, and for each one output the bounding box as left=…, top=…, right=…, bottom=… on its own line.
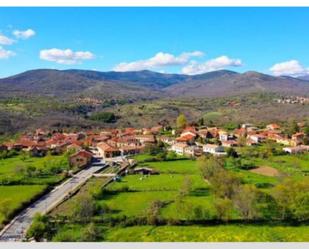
left=0, top=120, right=309, bottom=167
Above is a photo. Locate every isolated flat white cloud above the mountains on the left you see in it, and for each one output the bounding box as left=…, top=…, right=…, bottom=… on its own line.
left=40, top=48, right=94, bottom=65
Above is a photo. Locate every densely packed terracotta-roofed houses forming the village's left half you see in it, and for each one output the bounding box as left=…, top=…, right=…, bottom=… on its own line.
left=0, top=126, right=162, bottom=167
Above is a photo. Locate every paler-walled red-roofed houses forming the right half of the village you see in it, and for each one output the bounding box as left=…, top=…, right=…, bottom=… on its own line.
left=167, top=124, right=309, bottom=156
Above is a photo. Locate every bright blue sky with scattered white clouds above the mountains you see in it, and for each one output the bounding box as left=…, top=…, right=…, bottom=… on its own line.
left=0, top=7, right=309, bottom=77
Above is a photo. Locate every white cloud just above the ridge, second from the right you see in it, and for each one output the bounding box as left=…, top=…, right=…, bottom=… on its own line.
left=182, top=55, right=242, bottom=75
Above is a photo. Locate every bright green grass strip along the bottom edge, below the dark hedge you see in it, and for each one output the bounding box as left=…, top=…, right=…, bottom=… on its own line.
left=106, top=225, right=309, bottom=242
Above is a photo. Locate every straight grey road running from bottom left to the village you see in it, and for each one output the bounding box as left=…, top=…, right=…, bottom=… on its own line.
left=0, top=164, right=107, bottom=241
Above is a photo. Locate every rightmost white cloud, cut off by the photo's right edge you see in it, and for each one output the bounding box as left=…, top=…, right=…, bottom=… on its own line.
left=269, top=60, right=309, bottom=76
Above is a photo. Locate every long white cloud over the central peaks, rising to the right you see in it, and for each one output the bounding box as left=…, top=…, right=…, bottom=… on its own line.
left=114, top=51, right=204, bottom=72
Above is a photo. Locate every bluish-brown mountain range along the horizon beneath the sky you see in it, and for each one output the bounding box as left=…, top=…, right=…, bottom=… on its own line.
left=0, top=69, right=309, bottom=99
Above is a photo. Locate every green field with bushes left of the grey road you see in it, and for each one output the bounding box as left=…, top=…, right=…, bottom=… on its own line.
left=0, top=154, right=69, bottom=227
